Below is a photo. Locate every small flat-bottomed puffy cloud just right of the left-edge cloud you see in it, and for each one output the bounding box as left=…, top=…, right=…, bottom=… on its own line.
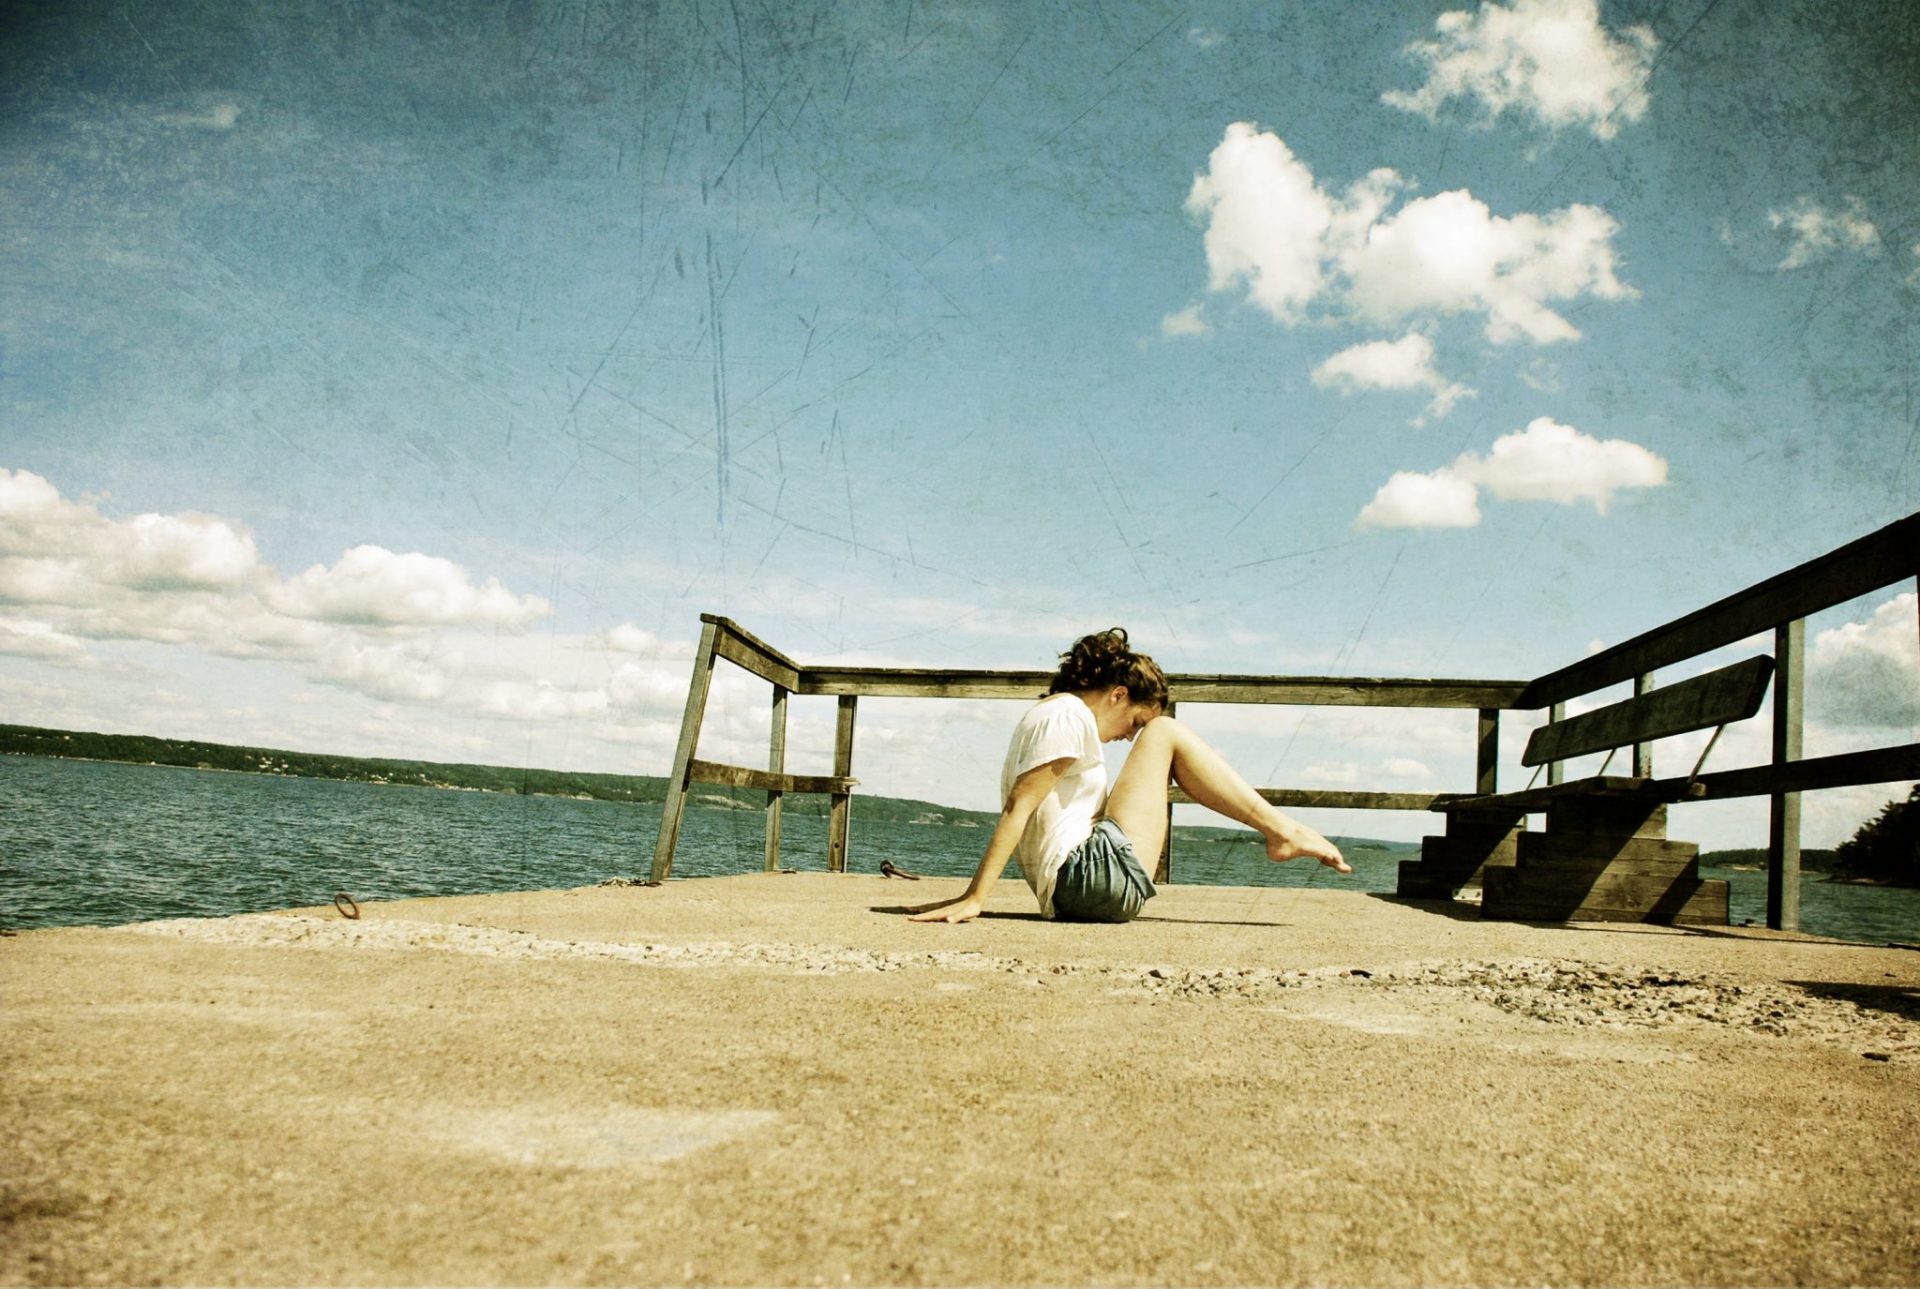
left=271, top=546, right=553, bottom=628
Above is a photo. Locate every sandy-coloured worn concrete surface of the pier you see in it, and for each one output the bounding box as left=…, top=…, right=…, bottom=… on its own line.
left=0, top=874, right=1920, bottom=1285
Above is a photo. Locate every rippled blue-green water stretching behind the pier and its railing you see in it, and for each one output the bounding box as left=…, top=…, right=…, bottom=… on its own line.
left=0, top=755, right=1920, bottom=941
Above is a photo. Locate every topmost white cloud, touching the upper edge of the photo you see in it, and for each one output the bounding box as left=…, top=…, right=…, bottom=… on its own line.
left=1380, top=0, right=1659, bottom=138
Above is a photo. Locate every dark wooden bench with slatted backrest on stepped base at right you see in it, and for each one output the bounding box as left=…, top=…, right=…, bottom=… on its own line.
left=1400, top=657, right=1774, bottom=926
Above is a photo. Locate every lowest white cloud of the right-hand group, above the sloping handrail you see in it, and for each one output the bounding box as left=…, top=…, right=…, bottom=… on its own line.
left=1357, top=417, right=1667, bottom=528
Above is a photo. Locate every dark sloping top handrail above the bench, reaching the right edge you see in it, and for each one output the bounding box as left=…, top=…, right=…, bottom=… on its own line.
left=1515, top=513, right=1920, bottom=707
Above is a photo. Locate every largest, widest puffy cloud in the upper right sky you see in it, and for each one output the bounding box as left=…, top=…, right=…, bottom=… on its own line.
left=1187, top=121, right=1636, bottom=344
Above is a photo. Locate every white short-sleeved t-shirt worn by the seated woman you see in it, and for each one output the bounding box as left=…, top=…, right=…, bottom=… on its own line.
left=1000, top=693, right=1106, bottom=918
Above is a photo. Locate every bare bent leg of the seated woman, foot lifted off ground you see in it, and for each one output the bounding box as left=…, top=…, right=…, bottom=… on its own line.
left=1106, top=717, right=1352, bottom=872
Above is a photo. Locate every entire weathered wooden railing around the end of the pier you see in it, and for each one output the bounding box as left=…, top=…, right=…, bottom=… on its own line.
left=653, top=515, right=1920, bottom=930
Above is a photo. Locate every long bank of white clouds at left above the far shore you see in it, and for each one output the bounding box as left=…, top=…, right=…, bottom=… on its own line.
left=0, top=469, right=618, bottom=720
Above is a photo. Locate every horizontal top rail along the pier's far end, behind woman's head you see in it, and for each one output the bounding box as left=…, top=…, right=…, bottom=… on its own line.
left=797, top=667, right=1524, bottom=709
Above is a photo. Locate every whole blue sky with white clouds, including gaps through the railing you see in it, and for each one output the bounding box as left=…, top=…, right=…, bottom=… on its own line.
left=0, top=0, right=1920, bottom=845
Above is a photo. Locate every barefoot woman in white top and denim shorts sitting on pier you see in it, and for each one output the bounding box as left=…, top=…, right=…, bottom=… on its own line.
left=908, top=626, right=1352, bottom=922
